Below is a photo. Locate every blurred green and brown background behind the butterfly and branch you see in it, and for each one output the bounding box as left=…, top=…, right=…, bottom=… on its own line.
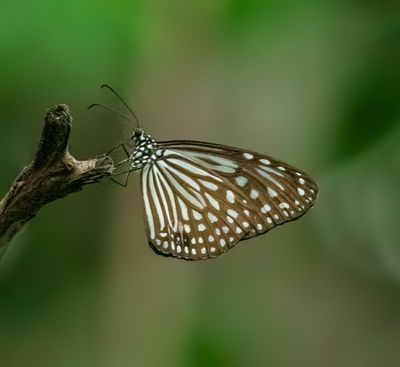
left=0, top=0, right=400, bottom=367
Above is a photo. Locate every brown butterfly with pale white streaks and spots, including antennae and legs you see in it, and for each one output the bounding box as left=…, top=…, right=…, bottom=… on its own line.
left=89, top=85, right=318, bottom=260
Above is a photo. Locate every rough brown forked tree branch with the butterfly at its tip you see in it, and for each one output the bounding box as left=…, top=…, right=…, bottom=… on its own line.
left=0, top=104, right=114, bottom=258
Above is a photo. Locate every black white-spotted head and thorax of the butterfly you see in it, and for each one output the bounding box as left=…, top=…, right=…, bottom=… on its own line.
left=130, top=129, right=157, bottom=170
